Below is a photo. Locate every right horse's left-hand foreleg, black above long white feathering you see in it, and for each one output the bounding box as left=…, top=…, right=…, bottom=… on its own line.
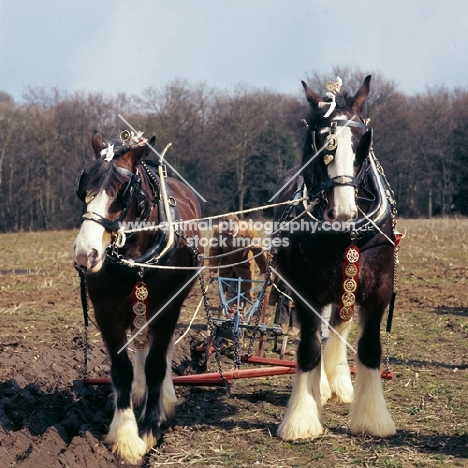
left=278, top=318, right=323, bottom=440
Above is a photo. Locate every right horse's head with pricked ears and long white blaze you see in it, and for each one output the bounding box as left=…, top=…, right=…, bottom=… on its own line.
left=302, top=75, right=372, bottom=222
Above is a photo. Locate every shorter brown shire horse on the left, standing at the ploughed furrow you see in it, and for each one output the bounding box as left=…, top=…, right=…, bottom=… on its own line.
left=74, top=131, right=201, bottom=463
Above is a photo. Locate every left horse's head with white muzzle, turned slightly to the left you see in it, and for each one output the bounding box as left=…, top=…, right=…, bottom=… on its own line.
left=73, top=132, right=154, bottom=273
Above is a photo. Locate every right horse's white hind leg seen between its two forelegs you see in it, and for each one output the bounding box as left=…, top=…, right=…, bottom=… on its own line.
left=322, top=320, right=354, bottom=403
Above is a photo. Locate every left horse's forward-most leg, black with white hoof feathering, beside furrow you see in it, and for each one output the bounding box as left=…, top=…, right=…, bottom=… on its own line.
left=105, top=350, right=146, bottom=464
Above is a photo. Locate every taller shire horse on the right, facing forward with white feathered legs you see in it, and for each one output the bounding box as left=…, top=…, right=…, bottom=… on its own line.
left=272, top=76, right=396, bottom=441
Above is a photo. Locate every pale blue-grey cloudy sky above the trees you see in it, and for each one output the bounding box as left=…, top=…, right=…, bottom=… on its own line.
left=0, top=0, right=468, bottom=101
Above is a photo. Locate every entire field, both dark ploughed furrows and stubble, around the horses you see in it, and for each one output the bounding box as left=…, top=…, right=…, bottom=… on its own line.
left=0, top=224, right=468, bottom=468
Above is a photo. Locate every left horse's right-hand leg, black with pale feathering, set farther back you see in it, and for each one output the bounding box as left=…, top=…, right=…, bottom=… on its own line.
left=140, top=337, right=177, bottom=450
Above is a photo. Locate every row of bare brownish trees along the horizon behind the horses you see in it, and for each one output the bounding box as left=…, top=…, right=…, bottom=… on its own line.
left=0, top=69, right=468, bottom=231
